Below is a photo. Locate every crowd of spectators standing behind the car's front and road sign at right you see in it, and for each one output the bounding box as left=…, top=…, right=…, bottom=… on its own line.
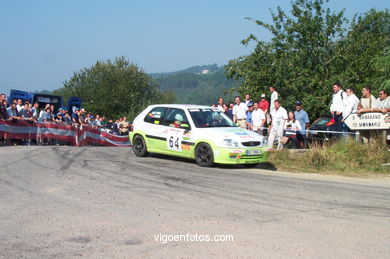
left=213, top=85, right=390, bottom=148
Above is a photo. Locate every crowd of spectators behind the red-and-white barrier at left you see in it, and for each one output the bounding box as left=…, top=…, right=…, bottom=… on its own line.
left=0, top=94, right=130, bottom=146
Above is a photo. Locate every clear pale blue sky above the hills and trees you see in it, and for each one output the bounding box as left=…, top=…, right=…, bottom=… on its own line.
left=0, top=0, right=390, bottom=95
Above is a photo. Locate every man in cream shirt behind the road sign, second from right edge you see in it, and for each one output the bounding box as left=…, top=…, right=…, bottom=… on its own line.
left=358, top=86, right=376, bottom=144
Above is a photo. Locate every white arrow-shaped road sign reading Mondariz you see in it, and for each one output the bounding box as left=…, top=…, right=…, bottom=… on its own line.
left=345, top=112, right=390, bottom=130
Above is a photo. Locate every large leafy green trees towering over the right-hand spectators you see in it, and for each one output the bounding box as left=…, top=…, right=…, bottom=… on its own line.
left=225, top=0, right=389, bottom=119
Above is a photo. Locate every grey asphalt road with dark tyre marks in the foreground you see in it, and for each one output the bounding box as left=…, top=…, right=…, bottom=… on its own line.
left=0, top=146, right=390, bottom=258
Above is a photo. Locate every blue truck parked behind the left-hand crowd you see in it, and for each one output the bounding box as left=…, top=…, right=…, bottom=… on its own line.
left=8, top=89, right=82, bottom=114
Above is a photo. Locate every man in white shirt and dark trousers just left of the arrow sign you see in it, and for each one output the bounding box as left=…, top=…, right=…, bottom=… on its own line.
left=330, top=82, right=347, bottom=132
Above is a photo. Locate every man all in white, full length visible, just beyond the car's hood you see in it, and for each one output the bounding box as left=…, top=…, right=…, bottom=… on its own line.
left=268, top=100, right=288, bottom=148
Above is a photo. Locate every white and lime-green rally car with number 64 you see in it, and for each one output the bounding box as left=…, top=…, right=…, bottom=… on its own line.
left=129, top=104, right=267, bottom=167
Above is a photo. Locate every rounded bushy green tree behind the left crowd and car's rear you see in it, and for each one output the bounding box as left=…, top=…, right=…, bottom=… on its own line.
left=55, top=57, right=174, bottom=119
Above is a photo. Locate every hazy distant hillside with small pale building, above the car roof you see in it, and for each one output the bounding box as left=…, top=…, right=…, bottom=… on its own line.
left=151, top=64, right=238, bottom=105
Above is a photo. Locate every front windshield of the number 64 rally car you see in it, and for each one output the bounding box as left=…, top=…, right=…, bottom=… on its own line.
left=188, top=108, right=237, bottom=128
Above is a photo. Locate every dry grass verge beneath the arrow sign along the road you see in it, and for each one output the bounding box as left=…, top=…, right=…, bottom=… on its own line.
left=269, top=138, right=390, bottom=176
